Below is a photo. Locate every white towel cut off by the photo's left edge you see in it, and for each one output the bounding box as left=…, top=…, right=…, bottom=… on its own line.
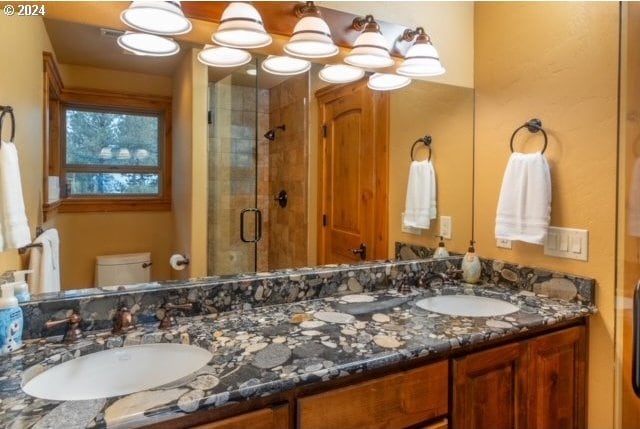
left=0, top=142, right=31, bottom=251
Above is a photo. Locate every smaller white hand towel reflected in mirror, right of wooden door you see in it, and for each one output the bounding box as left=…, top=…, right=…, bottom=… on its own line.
left=402, top=161, right=437, bottom=229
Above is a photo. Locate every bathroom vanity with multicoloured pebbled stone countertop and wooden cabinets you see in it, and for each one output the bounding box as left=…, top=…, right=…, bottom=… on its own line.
left=0, top=258, right=596, bottom=428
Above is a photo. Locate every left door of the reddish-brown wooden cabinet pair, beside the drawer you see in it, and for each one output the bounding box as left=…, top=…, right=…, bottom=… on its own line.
left=451, top=343, right=528, bottom=429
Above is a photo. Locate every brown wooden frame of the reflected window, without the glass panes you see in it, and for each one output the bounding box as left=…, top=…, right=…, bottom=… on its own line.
left=57, top=89, right=171, bottom=213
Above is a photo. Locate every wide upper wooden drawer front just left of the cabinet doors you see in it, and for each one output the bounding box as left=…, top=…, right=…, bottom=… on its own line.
left=298, top=361, right=449, bottom=429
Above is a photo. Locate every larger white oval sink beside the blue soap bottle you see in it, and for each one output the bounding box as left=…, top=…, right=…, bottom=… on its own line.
left=22, top=343, right=213, bottom=401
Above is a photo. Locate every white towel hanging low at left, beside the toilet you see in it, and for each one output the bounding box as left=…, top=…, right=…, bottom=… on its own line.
left=29, top=228, right=60, bottom=294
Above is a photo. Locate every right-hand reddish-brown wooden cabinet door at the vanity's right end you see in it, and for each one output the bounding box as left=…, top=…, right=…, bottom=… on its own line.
left=528, top=326, right=586, bottom=429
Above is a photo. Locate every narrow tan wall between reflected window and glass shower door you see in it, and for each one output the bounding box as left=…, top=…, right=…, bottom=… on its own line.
left=172, top=49, right=207, bottom=278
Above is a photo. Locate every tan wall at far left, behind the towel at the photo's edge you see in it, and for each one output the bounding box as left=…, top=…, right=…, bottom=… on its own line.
left=0, top=14, right=52, bottom=273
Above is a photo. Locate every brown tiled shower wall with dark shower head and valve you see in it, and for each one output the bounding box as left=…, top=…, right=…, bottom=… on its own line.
left=268, top=73, right=309, bottom=270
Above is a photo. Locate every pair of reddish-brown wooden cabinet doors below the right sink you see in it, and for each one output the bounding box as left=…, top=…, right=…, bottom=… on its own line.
left=451, top=326, right=586, bottom=429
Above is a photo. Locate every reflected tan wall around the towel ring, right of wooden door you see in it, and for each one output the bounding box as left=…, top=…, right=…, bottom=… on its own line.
left=389, top=81, right=473, bottom=257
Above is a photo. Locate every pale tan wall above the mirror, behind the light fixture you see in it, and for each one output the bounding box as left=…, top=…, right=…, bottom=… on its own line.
left=316, top=1, right=473, bottom=88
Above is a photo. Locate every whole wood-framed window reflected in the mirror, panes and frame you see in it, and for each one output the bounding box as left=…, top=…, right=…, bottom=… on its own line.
left=59, top=89, right=171, bottom=212
